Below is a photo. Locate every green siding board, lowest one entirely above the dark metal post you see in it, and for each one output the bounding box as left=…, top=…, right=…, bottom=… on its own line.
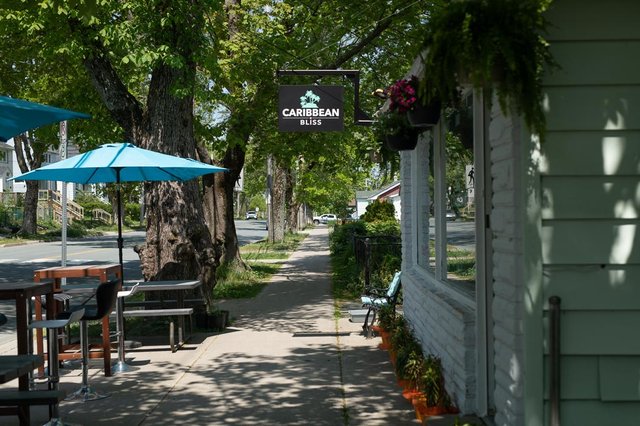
left=541, top=220, right=640, bottom=265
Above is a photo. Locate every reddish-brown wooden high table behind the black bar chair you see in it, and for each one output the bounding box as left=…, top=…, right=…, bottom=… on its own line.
left=33, top=263, right=122, bottom=376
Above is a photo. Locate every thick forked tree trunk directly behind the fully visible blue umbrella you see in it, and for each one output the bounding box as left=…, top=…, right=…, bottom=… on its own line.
left=78, top=11, right=217, bottom=309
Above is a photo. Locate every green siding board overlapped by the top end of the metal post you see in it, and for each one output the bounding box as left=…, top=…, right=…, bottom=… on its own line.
left=543, top=265, right=640, bottom=310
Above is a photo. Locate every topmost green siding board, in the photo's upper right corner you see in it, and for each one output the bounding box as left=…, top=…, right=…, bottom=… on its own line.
left=547, top=0, right=640, bottom=44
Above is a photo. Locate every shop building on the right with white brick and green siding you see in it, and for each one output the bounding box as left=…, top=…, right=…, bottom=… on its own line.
left=400, top=0, right=640, bottom=426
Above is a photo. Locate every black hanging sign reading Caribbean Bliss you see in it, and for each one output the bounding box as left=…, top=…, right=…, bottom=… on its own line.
left=278, top=86, right=344, bottom=132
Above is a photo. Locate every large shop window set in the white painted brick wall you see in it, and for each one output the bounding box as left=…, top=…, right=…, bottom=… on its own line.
left=416, top=92, right=476, bottom=291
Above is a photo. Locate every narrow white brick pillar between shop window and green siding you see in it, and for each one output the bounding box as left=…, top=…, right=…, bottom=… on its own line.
left=490, top=102, right=525, bottom=426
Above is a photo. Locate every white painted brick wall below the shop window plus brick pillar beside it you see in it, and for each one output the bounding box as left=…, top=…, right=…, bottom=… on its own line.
left=401, top=99, right=525, bottom=426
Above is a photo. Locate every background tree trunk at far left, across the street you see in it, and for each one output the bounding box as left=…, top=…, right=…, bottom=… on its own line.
left=13, top=134, right=42, bottom=235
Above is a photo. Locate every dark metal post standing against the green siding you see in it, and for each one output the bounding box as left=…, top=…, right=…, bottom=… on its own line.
left=549, top=296, right=561, bottom=426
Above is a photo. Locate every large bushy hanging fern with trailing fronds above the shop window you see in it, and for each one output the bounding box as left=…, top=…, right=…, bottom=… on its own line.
left=422, top=0, right=555, bottom=138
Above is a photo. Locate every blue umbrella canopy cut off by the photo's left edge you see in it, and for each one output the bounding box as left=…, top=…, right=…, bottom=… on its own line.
left=0, top=96, right=91, bottom=142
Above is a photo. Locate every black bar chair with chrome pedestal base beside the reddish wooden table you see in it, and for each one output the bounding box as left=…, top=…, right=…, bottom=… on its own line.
left=58, top=280, right=120, bottom=402
